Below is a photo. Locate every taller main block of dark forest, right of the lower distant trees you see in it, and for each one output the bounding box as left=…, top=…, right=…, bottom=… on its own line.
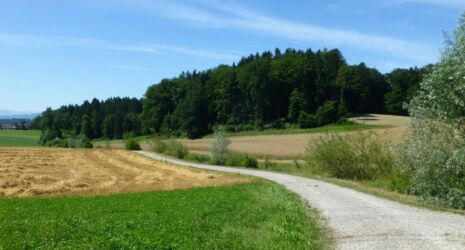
left=143, top=49, right=428, bottom=138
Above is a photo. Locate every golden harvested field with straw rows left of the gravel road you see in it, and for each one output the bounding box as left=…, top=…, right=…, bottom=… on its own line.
left=0, top=148, right=251, bottom=197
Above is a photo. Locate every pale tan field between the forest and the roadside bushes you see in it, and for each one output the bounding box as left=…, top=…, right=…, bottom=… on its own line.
left=180, top=115, right=409, bottom=159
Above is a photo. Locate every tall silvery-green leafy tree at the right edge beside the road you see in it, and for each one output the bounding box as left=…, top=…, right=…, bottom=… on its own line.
left=399, top=14, right=465, bottom=209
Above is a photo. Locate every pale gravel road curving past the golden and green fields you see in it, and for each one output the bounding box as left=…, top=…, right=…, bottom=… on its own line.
left=139, top=151, right=465, bottom=250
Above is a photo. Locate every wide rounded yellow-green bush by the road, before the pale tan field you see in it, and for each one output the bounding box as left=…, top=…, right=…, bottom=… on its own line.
left=307, top=133, right=394, bottom=180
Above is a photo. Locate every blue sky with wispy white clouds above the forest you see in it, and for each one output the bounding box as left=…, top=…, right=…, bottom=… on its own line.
left=0, top=0, right=465, bottom=111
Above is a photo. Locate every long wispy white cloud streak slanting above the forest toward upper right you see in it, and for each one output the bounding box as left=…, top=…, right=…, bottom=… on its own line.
left=107, top=0, right=436, bottom=64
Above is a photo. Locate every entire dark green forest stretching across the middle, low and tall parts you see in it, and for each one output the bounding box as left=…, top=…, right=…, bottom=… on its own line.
left=31, top=49, right=432, bottom=143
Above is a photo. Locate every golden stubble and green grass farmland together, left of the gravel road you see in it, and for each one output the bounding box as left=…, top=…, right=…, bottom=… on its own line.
left=0, top=148, right=327, bottom=249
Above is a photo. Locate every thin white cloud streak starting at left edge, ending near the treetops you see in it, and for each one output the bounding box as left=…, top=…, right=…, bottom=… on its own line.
left=0, top=33, right=240, bottom=61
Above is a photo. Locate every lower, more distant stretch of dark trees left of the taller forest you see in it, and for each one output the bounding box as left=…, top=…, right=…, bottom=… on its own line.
left=35, top=97, right=142, bottom=143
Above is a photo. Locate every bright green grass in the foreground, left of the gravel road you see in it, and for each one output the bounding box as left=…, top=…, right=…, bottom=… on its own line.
left=0, top=181, right=328, bottom=249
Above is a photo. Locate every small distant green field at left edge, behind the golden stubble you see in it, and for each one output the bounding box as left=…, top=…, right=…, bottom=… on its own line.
left=0, top=130, right=40, bottom=147
